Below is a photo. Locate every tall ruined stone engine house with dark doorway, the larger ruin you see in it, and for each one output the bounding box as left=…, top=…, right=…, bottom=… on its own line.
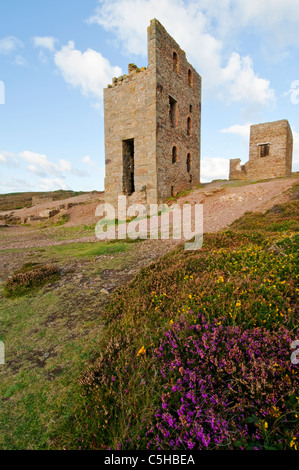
left=104, top=19, right=201, bottom=207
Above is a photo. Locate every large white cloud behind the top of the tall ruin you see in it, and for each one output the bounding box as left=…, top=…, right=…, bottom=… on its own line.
left=89, top=0, right=274, bottom=104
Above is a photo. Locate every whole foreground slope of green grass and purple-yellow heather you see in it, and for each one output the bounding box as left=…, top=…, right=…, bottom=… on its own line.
left=0, top=196, right=299, bottom=449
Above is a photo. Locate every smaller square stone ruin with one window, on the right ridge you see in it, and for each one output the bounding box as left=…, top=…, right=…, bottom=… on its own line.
left=229, top=119, right=293, bottom=180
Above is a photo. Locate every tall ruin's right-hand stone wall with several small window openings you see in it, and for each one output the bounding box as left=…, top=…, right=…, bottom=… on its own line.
left=148, top=20, right=201, bottom=202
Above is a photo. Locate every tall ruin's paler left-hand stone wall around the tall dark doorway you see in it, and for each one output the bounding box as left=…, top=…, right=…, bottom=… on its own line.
left=104, top=66, right=157, bottom=206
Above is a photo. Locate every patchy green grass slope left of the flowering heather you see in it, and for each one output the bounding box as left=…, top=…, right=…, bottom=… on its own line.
left=0, top=241, right=142, bottom=449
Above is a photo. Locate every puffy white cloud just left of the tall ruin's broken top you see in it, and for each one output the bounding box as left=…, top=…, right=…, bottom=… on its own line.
left=54, top=41, right=121, bottom=99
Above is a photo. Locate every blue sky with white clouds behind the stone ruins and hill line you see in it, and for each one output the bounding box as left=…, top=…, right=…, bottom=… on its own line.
left=0, top=0, right=299, bottom=193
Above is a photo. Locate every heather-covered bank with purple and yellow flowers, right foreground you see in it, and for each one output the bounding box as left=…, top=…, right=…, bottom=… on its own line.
left=52, top=201, right=299, bottom=450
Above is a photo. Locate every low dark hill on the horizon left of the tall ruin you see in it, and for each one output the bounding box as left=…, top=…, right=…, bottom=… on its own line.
left=0, top=189, right=86, bottom=211
